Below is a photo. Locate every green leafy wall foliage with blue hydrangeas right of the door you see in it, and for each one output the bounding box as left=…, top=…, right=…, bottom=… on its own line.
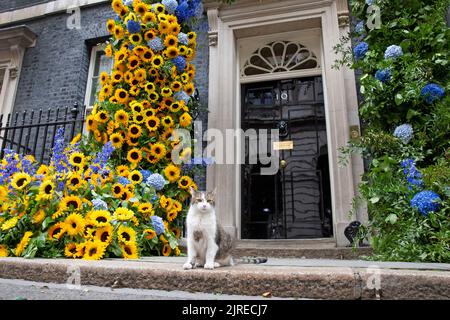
left=335, top=0, right=450, bottom=262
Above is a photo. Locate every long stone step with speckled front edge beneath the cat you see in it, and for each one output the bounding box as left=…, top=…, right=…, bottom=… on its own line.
left=0, top=257, right=450, bottom=299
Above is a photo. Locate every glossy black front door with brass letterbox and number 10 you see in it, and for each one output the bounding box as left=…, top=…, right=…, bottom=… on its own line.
left=241, top=76, right=333, bottom=239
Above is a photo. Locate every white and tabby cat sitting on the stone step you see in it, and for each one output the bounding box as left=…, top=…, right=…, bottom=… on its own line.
left=183, top=188, right=267, bottom=269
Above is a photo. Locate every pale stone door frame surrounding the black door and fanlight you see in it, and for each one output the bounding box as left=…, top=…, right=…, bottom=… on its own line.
left=207, top=0, right=365, bottom=246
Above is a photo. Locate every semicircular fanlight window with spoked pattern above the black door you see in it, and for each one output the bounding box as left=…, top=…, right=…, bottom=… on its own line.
left=241, top=41, right=319, bottom=77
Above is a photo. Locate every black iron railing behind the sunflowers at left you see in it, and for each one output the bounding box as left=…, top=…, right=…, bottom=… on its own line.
left=0, top=103, right=85, bottom=164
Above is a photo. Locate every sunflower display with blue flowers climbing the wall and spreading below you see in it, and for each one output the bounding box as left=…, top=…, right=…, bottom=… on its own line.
left=0, top=0, right=203, bottom=260
